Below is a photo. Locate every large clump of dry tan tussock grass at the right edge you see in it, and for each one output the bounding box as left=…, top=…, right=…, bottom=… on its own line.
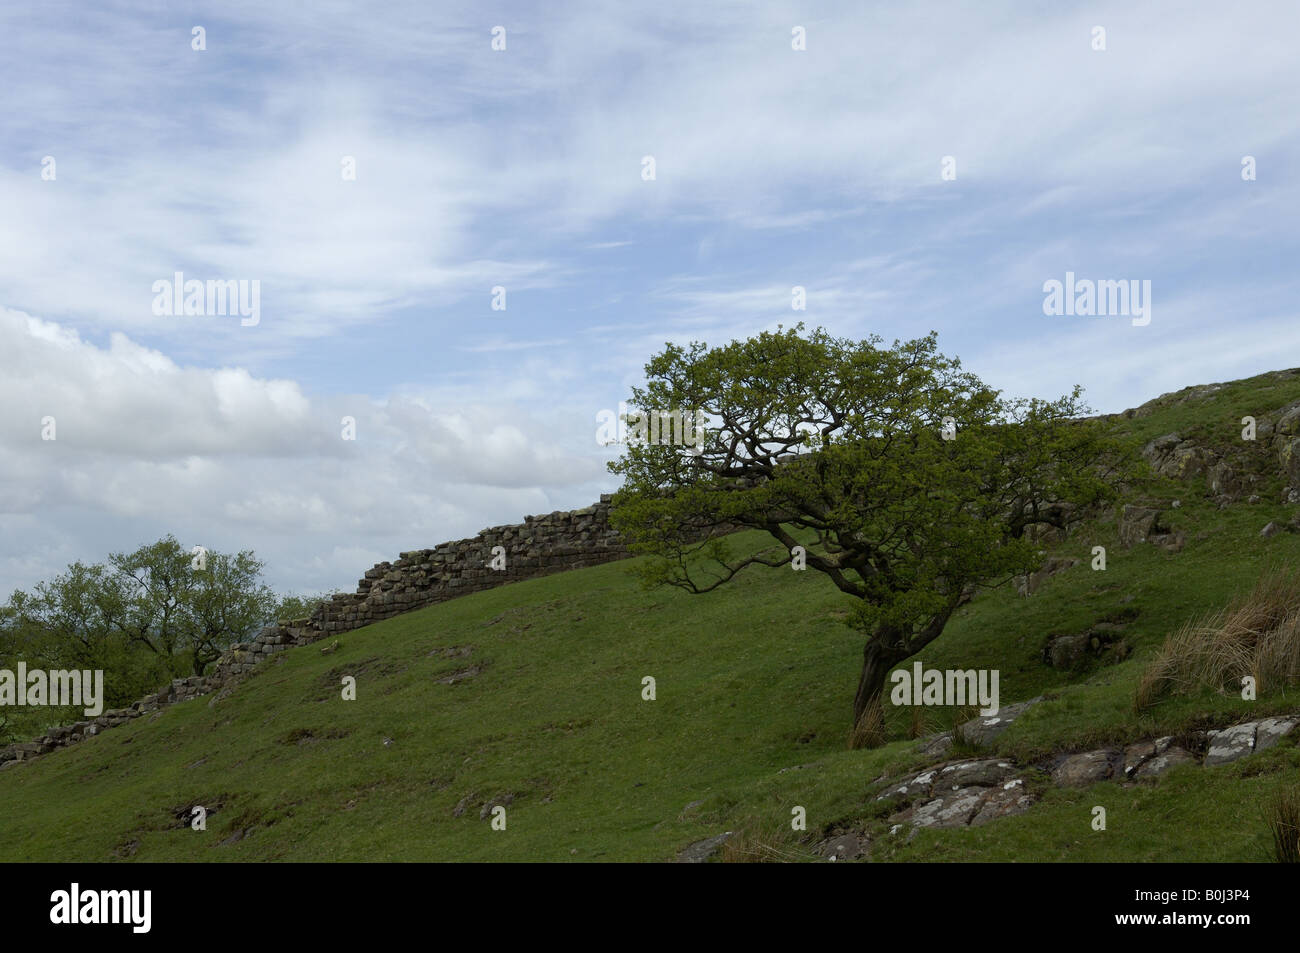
left=1134, top=566, right=1300, bottom=711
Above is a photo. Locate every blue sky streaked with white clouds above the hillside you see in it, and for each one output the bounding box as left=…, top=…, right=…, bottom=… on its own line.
left=0, top=0, right=1300, bottom=598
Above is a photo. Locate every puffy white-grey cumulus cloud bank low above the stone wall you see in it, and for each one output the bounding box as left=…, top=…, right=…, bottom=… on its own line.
left=0, top=308, right=602, bottom=589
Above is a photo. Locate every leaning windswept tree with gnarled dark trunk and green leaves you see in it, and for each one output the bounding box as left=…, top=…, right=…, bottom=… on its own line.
left=610, top=325, right=1112, bottom=737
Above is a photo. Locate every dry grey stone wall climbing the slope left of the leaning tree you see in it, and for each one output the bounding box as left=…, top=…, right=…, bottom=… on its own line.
left=0, top=495, right=629, bottom=768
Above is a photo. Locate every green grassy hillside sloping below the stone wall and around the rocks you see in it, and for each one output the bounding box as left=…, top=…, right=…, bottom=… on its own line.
left=0, top=377, right=1300, bottom=861
